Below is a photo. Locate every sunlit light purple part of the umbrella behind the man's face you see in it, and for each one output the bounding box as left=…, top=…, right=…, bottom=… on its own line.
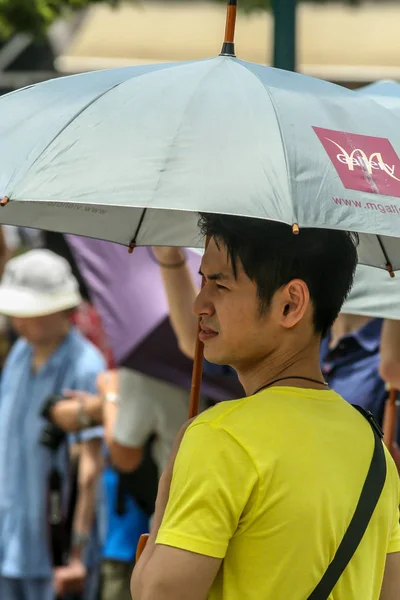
left=66, top=235, right=200, bottom=363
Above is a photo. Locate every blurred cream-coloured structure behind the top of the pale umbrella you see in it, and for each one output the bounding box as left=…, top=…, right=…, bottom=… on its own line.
left=55, top=0, right=400, bottom=86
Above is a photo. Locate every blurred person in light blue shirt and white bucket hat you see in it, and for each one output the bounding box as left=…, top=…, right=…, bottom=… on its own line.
left=0, top=250, right=105, bottom=600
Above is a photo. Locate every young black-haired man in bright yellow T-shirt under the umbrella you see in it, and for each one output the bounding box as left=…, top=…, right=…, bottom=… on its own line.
left=131, top=215, right=400, bottom=600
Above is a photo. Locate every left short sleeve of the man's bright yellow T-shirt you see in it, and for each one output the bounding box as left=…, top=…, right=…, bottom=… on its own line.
left=157, top=423, right=258, bottom=558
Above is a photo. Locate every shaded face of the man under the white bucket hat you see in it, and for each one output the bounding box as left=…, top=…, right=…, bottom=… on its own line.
left=11, top=313, right=68, bottom=346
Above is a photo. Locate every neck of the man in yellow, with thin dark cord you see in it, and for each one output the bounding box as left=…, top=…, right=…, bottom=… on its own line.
left=237, top=341, right=326, bottom=396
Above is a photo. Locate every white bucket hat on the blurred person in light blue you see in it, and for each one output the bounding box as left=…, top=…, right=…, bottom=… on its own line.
left=0, top=250, right=82, bottom=318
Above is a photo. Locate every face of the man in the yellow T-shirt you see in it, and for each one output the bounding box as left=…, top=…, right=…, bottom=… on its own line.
left=194, top=240, right=281, bottom=370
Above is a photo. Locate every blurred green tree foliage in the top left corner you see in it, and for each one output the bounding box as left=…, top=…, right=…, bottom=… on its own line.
left=0, top=0, right=122, bottom=39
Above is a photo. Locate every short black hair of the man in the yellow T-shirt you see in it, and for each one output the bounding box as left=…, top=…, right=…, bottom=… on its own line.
left=199, top=213, right=358, bottom=335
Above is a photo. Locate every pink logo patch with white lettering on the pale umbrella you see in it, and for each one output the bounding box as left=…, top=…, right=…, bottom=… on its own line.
left=313, top=127, right=400, bottom=198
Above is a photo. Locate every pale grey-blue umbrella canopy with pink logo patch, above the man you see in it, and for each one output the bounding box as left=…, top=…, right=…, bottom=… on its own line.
left=0, top=56, right=400, bottom=269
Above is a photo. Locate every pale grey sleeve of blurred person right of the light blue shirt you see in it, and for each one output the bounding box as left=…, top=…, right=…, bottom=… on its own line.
left=114, top=369, right=156, bottom=448
